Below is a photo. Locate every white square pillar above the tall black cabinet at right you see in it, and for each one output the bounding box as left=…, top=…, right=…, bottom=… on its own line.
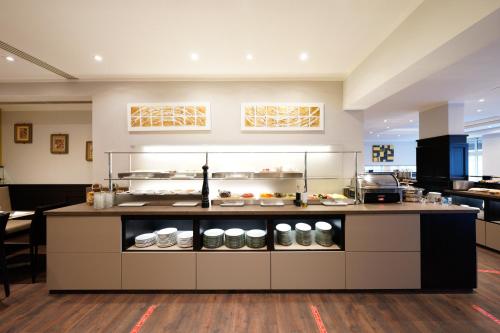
left=418, top=103, right=464, bottom=139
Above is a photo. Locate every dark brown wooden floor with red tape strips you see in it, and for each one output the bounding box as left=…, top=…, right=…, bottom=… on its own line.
left=0, top=248, right=500, bottom=333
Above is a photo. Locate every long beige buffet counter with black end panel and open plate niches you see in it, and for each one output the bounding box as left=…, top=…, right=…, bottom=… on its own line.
left=46, top=203, right=477, bottom=292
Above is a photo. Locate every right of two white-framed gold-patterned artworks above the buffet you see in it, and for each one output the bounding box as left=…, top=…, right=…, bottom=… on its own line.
left=241, top=103, right=325, bottom=131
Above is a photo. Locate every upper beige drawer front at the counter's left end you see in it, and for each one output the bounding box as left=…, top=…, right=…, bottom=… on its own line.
left=47, top=216, right=122, bottom=253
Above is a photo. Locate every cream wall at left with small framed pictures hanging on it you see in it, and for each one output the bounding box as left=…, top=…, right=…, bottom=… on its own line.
left=2, top=111, right=92, bottom=184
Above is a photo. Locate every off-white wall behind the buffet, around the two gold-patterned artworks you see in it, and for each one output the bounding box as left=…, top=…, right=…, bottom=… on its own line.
left=0, top=81, right=363, bottom=182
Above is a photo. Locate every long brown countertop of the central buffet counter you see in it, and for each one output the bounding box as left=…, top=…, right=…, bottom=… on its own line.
left=45, top=202, right=479, bottom=216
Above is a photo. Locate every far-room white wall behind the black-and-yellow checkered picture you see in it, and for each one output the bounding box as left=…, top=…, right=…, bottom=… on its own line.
left=363, top=140, right=417, bottom=166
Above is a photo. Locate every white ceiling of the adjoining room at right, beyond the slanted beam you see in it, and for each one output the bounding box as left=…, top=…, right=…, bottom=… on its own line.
left=364, top=35, right=500, bottom=141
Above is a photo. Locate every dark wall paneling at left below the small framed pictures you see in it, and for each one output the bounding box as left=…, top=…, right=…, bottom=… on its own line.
left=4, top=184, right=90, bottom=210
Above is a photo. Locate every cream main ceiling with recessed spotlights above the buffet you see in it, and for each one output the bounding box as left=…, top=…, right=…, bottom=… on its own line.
left=0, top=0, right=422, bottom=81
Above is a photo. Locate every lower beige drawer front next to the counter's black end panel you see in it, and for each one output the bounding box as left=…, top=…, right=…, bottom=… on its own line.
left=346, top=252, right=420, bottom=289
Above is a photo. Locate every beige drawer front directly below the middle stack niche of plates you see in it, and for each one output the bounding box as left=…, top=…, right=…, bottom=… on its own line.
left=196, top=252, right=271, bottom=290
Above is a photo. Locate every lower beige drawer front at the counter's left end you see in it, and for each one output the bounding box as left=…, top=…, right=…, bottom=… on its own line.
left=47, top=253, right=121, bottom=290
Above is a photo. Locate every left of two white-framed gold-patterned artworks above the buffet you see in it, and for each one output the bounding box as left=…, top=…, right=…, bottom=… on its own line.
left=127, top=102, right=211, bottom=132
